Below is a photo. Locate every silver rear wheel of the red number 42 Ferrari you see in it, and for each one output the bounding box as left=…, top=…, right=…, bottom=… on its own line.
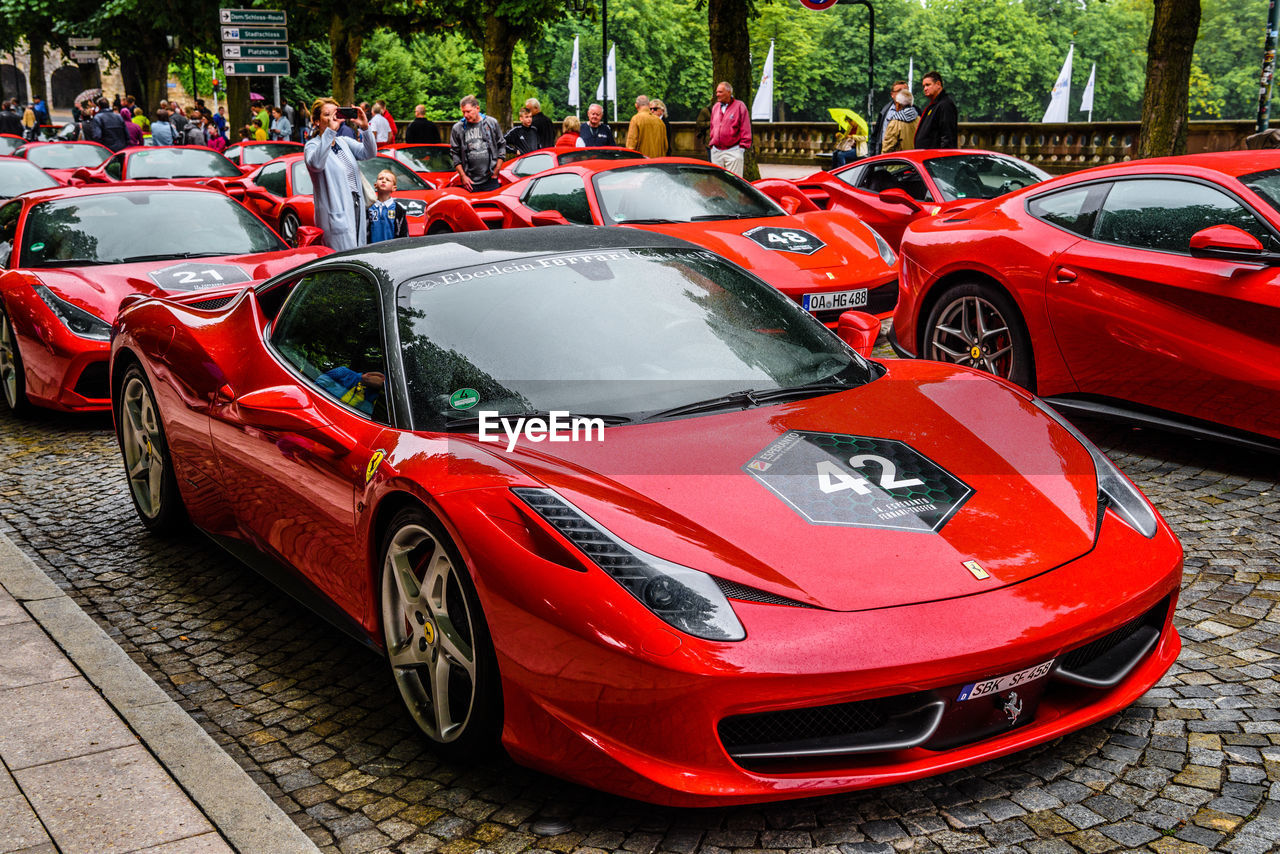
left=115, top=365, right=187, bottom=535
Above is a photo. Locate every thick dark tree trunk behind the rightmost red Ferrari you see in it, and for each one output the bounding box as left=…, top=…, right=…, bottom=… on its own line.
left=1138, top=0, right=1199, bottom=157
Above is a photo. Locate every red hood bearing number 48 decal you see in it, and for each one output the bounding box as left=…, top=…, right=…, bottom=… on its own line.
left=628, top=211, right=892, bottom=279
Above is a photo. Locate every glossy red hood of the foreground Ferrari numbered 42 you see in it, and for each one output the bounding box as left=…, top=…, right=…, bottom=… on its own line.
left=465, top=362, right=1098, bottom=611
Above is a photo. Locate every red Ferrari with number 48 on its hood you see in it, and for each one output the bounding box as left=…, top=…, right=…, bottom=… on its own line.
left=426, top=158, right=897, bottom=325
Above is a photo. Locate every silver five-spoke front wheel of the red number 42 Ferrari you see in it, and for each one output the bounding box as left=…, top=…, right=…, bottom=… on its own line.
left=381, top=507, right=502, bottom=759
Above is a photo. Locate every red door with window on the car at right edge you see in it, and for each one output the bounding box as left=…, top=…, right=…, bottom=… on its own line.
left=1046, top=175, right=1280, bottom=435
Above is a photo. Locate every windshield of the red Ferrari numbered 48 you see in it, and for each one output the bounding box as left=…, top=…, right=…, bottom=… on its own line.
left=593, top=164, right=782, bottom=225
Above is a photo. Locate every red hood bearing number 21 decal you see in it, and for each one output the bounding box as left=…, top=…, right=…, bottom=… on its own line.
left=28, top=246, right=330, bottom=323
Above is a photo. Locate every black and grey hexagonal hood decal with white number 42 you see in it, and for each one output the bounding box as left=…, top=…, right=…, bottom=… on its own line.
left=742, top=430, right=973, bottom=533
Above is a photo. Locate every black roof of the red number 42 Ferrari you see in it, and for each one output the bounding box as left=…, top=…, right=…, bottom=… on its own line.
left=316, top=225, right=705, bottom=284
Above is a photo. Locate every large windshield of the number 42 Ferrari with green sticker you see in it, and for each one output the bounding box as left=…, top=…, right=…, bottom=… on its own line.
left=397, top=248, right=870, bottom=430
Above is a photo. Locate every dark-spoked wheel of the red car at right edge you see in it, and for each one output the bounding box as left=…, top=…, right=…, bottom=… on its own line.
left=920, top=282, right=1036, bottom=391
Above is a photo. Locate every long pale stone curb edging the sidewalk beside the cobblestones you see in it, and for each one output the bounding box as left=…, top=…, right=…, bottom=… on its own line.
left=0, top=534, right=319, bottom=854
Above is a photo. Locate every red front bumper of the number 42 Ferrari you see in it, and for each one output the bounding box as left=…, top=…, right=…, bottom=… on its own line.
left=448, top=494, right=1181, bottom=807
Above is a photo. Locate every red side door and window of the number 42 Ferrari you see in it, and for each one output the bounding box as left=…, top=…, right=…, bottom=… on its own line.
left=211, top=268, right=393, bottom=627
